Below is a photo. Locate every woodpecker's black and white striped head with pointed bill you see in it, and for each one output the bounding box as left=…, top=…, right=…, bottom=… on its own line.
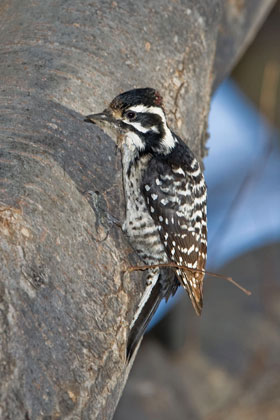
left=85, top=88, right=176, bottom=153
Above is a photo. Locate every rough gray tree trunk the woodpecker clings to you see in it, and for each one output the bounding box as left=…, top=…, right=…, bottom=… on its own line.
left=0, top=0, right=274, bottom=420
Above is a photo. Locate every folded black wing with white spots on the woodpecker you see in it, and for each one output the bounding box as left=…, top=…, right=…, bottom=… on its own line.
left=141, top=159, right=207, bottom=315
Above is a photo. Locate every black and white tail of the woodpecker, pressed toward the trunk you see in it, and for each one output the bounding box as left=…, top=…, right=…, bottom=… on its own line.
left=126, top=269, right=179, bottom=361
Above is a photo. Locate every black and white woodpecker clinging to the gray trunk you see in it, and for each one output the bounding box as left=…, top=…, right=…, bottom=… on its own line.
left=85, top=88, right=207, bottom=359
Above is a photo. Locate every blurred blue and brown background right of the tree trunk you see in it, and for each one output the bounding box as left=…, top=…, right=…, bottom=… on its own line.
left=114, top=1, right=280, bottom=420
